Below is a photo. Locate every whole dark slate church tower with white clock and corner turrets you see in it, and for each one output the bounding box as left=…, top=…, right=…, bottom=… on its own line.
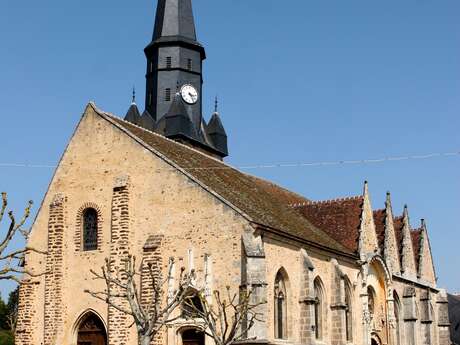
left=126, top=0, right=228, bottom=158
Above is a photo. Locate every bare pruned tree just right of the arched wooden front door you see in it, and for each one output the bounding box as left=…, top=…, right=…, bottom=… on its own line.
left=85, top=255, right=194, bottom=345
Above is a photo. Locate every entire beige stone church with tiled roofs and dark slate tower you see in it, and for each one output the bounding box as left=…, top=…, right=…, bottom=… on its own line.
left=16, top=0, right=451, bottom=345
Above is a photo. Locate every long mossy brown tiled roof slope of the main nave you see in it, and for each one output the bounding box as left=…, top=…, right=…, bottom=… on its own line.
left=95, top=109, right=352, bottom=254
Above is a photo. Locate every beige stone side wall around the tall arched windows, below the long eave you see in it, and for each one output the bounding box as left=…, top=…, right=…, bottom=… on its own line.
left=264, top=236, right=362, bottom=344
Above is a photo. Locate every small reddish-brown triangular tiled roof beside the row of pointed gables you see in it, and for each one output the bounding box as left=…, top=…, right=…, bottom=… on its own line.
left=295, top=196, right=364, bottom=253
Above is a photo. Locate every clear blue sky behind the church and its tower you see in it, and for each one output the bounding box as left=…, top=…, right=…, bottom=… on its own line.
left=0, top=0, right=460, bottom=295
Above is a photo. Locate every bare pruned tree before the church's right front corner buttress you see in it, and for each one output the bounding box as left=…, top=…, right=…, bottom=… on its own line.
left=181, top=286, right=266, bottom=345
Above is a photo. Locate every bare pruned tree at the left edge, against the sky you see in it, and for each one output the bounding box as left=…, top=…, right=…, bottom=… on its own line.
left=0, top=193, right=46, bottom=283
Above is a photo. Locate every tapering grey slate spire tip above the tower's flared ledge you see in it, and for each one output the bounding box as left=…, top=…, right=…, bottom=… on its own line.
left=153, top=0, right=196, bottom=41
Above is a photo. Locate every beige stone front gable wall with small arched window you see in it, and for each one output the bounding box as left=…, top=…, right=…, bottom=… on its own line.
left=18, top=110, right=247, bottom=345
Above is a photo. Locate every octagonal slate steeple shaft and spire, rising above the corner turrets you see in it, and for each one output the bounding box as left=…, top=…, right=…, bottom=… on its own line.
left=144, top=0, right=206, bottom=128
